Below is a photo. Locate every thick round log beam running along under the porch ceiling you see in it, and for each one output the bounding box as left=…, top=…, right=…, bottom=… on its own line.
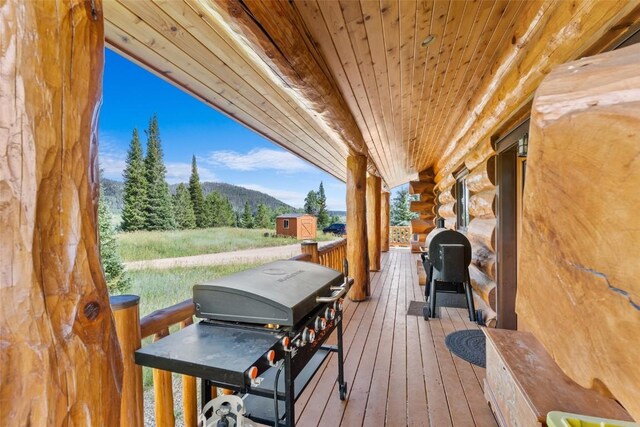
left=199, top=0, right=379, bottom=175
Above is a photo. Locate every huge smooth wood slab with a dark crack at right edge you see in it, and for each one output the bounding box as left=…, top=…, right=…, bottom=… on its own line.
left=516, top=45, right=640, bottom=420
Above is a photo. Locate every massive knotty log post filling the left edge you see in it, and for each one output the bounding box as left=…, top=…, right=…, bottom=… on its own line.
left=0, top=0, right=123, bottom=426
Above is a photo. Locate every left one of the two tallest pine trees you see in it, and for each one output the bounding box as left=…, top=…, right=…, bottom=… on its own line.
left=122, top=129, right=147, bottom=231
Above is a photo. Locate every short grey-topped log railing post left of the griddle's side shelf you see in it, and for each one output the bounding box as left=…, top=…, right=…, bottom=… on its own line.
left=110, top=295, right=144, bottom=427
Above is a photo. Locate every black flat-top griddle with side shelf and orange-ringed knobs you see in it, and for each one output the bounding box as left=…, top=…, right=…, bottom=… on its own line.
left=135, top=261, right=348, bottom=426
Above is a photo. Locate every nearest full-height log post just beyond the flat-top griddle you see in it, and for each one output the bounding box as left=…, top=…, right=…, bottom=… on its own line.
left=347, top=153, right=369, bottom=301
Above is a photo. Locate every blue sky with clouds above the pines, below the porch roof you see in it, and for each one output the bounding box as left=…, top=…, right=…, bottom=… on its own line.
left=99, top=49, right=345, bottom=210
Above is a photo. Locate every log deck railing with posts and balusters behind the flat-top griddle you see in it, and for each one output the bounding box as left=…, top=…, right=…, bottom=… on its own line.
left=111, top=239, right=347, bottom=427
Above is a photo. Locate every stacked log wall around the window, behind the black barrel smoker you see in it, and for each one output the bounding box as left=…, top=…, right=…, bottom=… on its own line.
left=436, top=155, right=496, bottom=326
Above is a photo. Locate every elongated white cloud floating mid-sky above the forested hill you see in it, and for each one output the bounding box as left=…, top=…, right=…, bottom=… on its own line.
left=206, top=148, right=313, bottom=173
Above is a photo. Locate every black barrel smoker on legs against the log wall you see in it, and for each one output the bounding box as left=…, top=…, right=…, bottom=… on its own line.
left=422, top=218, right=476, bottom=322
